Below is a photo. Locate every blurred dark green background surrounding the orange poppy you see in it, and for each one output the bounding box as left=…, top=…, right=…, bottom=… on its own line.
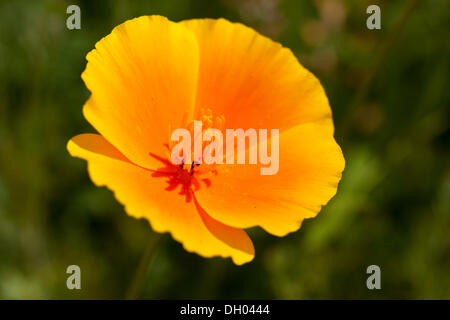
left=0, top=0, right=450, bottom=299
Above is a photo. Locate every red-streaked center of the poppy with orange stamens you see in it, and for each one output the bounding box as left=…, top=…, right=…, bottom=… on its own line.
left=150, top=109, right=225, bottom=202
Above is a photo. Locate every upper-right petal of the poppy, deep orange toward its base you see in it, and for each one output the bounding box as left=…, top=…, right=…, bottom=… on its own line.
left=181, top=19, right=333, bottom=132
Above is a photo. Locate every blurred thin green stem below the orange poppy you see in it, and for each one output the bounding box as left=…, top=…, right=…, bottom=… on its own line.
left=125, top=233, right=162, bottom=300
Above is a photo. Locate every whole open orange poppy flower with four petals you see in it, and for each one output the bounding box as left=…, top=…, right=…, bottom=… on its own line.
left=67, top=16, right=344, bottom=264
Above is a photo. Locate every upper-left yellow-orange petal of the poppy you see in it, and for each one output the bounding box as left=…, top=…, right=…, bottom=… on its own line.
left=82, top=16, right=199, bottom=168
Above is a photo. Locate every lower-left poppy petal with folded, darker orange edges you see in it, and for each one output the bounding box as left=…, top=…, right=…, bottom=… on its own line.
left=67, top=134, right=254, bottom=265
